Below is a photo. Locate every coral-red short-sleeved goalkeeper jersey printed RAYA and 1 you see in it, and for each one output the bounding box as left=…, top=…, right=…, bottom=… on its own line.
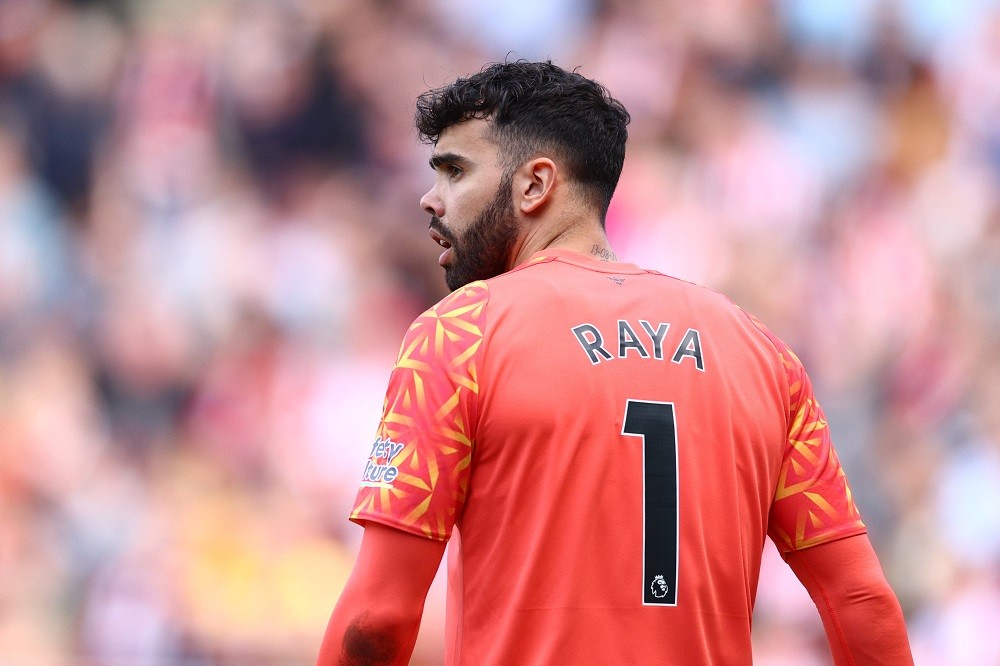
left=351, top=250, right=865, bottom=666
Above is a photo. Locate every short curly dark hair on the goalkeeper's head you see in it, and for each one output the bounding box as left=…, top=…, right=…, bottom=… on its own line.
left=416, top=60, right=629, bottom=223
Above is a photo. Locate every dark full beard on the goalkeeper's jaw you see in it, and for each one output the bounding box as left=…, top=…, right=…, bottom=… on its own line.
left=430, top=177, right=518, bottom=291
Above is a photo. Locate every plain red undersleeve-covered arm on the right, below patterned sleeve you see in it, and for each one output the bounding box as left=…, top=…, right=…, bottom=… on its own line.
left=787, top=536, right=913, bottom=666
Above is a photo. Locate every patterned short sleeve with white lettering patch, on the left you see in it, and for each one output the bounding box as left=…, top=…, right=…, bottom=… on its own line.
left=350, top=282, right=489, bottom=540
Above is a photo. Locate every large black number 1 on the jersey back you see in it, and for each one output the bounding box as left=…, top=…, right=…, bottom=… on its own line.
left=622, top=400, right=679, bottom=606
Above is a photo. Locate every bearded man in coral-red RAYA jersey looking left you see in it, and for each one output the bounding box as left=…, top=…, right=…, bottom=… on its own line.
left=319, top=62, right=911, bottom=666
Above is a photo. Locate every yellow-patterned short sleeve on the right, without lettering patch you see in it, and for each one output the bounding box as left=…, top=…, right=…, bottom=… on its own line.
left=751, top=317, right=867, bottom=553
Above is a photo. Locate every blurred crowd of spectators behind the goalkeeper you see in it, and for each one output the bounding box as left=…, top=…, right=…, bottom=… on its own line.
left=0, top=0, right=1000, bottom=666
